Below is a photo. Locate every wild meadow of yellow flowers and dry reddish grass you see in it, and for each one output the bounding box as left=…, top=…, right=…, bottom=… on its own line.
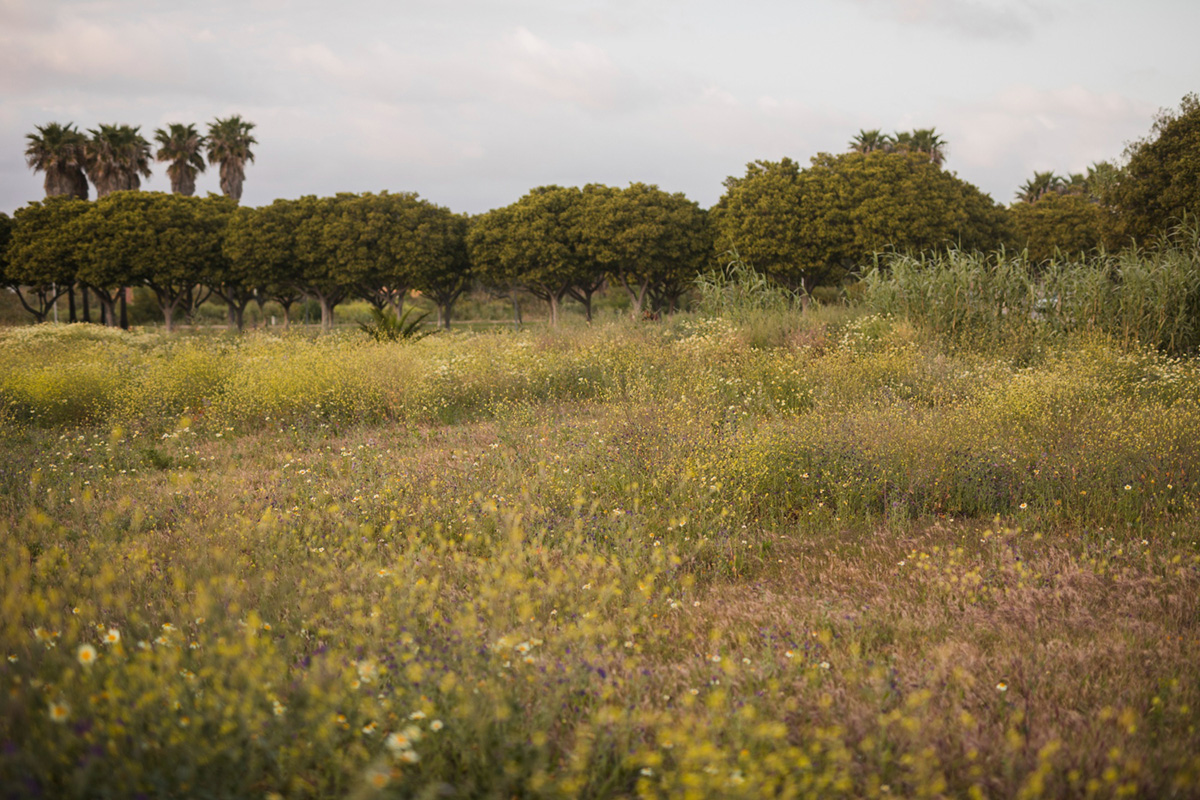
left=0, top=308, right=1200, bottom=798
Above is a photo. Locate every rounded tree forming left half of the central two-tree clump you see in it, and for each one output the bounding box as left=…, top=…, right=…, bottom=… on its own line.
left=468, top=186, right=593, bottom=325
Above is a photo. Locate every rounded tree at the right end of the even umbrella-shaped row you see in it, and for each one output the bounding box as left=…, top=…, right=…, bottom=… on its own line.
left=582, top=184, right=713, bottom=319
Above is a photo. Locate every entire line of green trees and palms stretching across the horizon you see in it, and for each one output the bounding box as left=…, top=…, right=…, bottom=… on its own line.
left=9, top=95, right=1200, bottom=329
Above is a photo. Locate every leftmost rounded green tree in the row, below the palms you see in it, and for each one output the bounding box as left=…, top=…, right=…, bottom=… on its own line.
left=4, top=196, right=90, bottom=323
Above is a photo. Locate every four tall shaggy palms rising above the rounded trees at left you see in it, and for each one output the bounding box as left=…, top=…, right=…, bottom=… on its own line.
left=25, top=115, right=258, bottom=203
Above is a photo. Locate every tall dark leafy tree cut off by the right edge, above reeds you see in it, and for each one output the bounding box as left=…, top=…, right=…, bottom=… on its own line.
left=1103, top=94, right=1200, bottom=247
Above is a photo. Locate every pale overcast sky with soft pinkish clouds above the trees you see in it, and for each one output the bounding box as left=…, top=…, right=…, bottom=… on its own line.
left=0, top=0, right=1200, bottom=213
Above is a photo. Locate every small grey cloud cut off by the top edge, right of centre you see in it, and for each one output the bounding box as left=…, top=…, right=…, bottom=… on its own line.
left=858, top=0, right=1046, bottom=41
